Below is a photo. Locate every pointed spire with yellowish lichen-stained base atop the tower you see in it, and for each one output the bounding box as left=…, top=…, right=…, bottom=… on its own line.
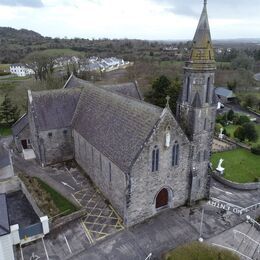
left=190, top=0, right=215, bottom=66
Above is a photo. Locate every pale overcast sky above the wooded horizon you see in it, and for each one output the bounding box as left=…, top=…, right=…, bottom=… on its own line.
left=0, top=0, right=260, bottom=40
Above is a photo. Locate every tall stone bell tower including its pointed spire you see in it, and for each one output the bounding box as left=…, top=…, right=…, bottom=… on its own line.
left=177, top=0, right=216, bottom=204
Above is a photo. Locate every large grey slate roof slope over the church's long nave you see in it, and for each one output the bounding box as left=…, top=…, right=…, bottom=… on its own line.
left=72, top=86, right=163, bottom=173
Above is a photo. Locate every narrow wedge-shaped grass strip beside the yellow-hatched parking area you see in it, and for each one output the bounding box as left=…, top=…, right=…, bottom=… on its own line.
left=36, top=178, right=77, bottom=215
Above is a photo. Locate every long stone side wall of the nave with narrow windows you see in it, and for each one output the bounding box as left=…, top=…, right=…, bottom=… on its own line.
left=73, top=130, right=126, bottom=217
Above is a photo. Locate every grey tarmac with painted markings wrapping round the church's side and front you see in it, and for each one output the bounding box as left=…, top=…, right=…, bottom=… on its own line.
left=12, top=154, right=260, bottom=260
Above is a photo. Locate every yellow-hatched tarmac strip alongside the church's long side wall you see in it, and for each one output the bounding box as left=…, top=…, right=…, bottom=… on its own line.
left=48, top=164, right=124, bottom=244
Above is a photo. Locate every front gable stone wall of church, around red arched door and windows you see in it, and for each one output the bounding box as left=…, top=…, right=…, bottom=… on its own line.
left=125, top=112, right=190, bottom=226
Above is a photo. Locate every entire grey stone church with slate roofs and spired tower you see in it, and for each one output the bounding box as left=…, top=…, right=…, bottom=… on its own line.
left=14, top=1, right=216, bottom=226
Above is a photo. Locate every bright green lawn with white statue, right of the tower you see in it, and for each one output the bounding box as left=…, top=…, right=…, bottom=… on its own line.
left=211, top=148, right=260, bottom=183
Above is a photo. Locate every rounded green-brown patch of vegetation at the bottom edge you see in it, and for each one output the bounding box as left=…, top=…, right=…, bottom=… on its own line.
left=163, top=242, right=239, bottom=260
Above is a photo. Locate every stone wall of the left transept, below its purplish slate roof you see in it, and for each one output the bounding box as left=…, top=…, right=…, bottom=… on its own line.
left=39, top=128, right=74, bottom=165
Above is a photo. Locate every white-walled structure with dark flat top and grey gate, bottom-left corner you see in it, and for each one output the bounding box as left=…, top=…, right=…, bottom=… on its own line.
left=0, top=191, right=49, bottom=260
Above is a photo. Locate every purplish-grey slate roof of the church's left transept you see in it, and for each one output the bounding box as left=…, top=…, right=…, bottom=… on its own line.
left=32, top=88, right=81, bottom=131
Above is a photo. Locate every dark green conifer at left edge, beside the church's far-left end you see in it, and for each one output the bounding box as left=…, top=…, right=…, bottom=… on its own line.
left=0, top=95, right=20, bottom=126
